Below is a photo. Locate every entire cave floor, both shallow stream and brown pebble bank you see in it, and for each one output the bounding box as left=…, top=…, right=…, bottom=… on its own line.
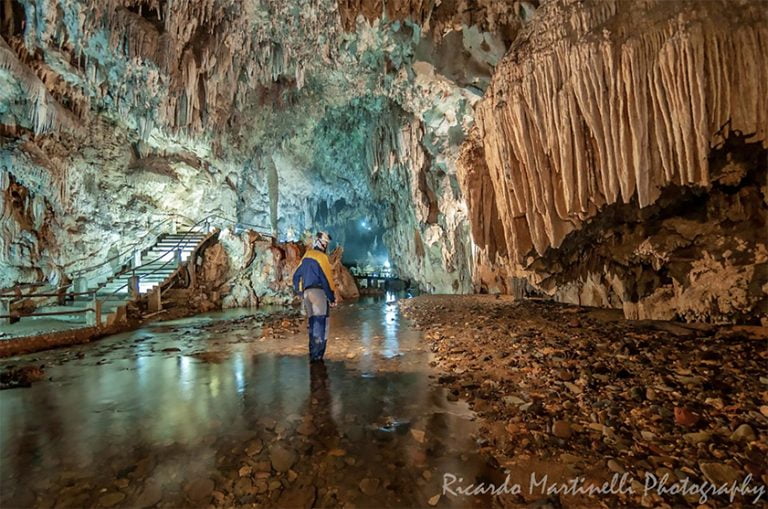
left=0, top=296, right=768, bottom=508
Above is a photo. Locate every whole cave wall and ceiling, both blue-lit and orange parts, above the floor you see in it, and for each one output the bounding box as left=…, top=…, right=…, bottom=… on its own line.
left=0, top=0, right=768, bottom=322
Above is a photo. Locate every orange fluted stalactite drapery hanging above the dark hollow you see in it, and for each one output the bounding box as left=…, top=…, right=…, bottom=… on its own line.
left=477, top=0, right=768, bottom=260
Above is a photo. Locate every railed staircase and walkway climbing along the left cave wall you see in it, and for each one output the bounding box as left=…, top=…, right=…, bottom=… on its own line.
left=0, top=214, right=265, bottom=339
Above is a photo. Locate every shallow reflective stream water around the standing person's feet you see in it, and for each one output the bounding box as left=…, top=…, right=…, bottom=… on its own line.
left=0, top=301, right=488, bottom=507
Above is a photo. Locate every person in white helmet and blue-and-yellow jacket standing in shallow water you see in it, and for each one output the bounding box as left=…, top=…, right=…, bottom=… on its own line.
left=293, top=232, right=336, bottom=362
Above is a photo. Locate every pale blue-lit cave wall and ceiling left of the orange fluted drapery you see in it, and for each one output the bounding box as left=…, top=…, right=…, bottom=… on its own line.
left=0, top=0, right=520, bottom=292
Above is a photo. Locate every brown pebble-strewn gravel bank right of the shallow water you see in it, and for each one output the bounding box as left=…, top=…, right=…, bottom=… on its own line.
left=401, top=296, right=768, bottom=507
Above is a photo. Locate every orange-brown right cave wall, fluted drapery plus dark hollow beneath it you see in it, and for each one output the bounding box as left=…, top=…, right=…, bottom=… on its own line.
left=460, top=0, right=768, bottom=321
